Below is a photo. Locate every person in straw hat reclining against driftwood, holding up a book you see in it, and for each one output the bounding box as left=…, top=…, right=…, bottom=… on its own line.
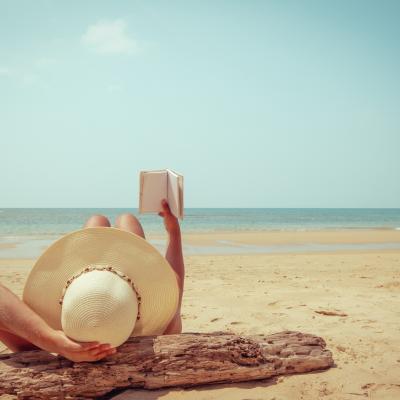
left=0, top=199, right=185, bottom=362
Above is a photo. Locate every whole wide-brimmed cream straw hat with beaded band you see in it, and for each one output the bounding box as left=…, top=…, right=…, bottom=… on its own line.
left=23, top=227, right=179, bottom=346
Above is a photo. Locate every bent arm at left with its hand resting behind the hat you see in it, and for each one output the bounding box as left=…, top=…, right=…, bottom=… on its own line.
left=0, top=284, right=115, bottom=362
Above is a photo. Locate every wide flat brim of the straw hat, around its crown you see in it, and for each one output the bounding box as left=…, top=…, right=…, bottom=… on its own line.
left=23, top=227, right=179, bottom=336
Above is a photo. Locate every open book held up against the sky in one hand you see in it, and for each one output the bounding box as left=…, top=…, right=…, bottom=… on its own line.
left=139, top=169, right=183, bottom=219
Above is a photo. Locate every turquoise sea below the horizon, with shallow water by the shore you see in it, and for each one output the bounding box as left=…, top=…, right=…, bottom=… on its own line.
left=0, top=208, right=400, bottom=258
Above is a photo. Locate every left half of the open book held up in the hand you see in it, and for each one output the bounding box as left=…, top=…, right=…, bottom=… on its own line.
left=139, top=170, right=168, bottom=213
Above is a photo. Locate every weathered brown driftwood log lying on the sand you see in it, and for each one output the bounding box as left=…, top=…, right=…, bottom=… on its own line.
left=0, top=331, right=333, bottom=399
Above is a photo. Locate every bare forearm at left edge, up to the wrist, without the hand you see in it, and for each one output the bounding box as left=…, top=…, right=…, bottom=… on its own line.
left=0, top=285, right=56, bottom=351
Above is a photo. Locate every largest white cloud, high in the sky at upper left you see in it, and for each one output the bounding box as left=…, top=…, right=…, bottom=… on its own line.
left=81, top=19, right=137, bottom=54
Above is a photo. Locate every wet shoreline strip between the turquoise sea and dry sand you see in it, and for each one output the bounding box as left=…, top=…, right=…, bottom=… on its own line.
left=0, top=229, right=400, bottom=259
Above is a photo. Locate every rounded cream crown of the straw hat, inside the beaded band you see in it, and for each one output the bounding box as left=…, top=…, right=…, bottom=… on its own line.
left=61, top=270, right=138, bottom=347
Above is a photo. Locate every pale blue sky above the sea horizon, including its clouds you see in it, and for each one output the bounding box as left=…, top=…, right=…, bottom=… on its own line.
left=0, top=0, right=400, bottom=207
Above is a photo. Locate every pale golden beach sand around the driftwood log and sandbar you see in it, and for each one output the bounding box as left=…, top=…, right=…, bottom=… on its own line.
left=0, top=230, right=400, bottom=400
